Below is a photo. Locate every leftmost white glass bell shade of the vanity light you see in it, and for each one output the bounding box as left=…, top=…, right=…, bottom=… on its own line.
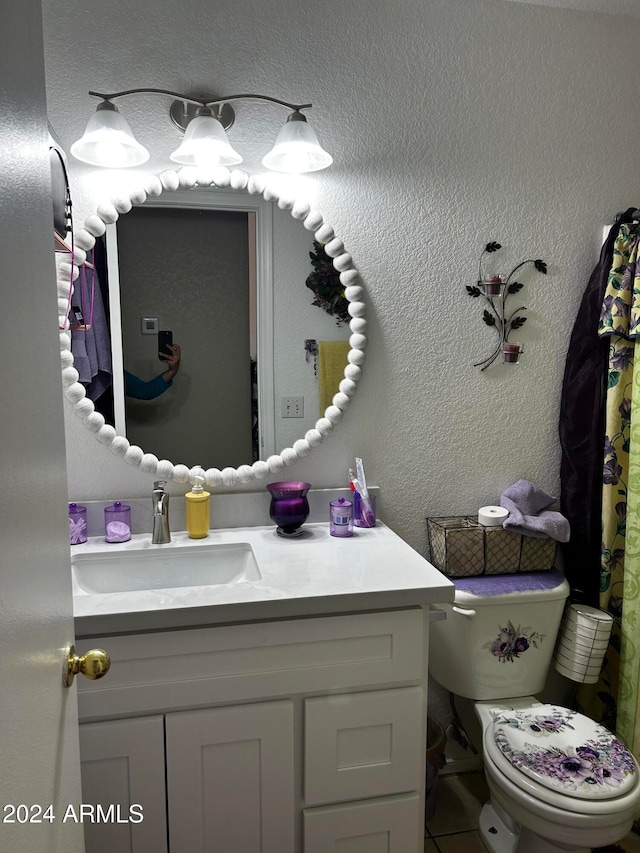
left=70, top=102, right=149, bottom=169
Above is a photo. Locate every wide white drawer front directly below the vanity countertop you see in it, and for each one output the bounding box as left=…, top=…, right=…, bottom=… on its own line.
left=78, top=608, right=427, bottom=720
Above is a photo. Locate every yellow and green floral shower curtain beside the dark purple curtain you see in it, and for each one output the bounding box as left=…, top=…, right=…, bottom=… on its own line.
left=579, top=224, right=640, bottom=757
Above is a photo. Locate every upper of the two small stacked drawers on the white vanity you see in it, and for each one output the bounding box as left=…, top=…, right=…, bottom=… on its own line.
left=304, top=687, right=426, bottom=805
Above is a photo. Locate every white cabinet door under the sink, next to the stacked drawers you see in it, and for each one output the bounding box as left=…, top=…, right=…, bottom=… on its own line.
left=166, top=702, right=294, bottom=853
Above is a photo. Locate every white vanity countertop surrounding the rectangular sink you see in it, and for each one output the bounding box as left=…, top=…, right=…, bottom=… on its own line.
left=72, top=522, right=454, bottom=637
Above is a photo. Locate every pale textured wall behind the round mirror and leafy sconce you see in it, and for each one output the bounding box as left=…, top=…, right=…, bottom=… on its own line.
left=45, top=0, right=640, bottom=551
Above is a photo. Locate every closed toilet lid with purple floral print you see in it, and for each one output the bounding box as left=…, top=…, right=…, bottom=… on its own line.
left=493, top=705, right=637, bottom=800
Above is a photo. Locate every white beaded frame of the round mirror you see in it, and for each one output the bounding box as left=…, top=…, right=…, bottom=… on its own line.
left=57, top=166, right=367, bottom=488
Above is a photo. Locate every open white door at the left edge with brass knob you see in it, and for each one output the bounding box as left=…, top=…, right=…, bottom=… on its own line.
left=0, top=0, right=84, bottom=853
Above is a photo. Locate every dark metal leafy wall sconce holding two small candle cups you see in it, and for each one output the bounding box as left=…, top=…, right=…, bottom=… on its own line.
left=467, top=241, right=547, bottom=370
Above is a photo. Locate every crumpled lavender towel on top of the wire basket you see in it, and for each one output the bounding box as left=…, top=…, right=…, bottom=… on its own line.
left=500, top=480, right=570, bottom=542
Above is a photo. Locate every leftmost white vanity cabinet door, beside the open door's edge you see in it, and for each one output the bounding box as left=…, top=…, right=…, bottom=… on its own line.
left=80, top=716, right=167, bottom=853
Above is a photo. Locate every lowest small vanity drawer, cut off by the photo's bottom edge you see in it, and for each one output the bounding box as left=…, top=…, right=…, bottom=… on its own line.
left=303, top=794, right=424, bottom=853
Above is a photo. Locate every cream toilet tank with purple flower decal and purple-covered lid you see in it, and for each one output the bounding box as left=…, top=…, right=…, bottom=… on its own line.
left=429, top=569, right=569, bottom=699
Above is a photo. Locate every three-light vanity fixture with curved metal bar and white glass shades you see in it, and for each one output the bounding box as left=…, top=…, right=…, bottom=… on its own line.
left=71, top=89, right=333, bottom=174
